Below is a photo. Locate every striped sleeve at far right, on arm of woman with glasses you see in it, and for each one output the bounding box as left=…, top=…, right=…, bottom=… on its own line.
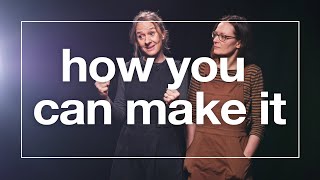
left=249, top=67, right=265, bottom=139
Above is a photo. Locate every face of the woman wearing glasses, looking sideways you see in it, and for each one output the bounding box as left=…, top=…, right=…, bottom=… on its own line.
left=213, top=22, right=241, bottom=57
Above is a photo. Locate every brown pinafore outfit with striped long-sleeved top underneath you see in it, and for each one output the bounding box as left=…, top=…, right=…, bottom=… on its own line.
left=185, top=63, right=264, bottom=180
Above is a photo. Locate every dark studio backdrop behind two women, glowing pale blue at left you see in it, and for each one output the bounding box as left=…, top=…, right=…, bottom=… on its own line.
left=0, top=0, right=319, bottom=179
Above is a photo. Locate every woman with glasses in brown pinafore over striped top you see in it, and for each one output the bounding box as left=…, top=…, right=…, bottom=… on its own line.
left=185, top=15, right=264, bottom=180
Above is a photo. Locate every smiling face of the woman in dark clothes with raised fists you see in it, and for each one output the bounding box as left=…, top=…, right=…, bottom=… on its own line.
left=136, top=22, right=164, bottom=57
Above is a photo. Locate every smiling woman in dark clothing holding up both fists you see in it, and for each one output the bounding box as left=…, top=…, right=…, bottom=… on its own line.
left=96, top=11, right=187, bottom=180
